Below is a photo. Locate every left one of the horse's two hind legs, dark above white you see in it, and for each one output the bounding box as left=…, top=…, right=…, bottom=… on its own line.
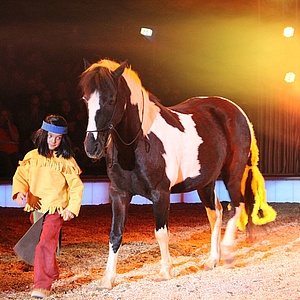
left=198, top=183, right=223, bottom=270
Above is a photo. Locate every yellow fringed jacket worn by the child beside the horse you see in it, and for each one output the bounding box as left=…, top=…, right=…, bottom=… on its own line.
left=12, top=149, right=83, bottom=216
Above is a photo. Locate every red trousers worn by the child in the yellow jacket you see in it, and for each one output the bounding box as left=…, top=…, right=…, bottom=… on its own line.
left=34, top=212, right=63, bottom=290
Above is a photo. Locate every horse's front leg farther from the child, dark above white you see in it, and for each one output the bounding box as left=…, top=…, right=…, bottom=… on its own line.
left=153, top=191, right=172, bottom=279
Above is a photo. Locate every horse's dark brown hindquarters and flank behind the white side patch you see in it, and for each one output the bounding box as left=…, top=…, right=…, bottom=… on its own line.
left=168, top=97, right=251, bottom=192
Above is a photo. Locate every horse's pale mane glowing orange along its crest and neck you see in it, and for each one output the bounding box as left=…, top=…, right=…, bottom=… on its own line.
left=89, top=59, right=160, bottom=136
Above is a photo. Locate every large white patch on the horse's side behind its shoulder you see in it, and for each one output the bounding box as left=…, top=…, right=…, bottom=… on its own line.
left=150, top=111, right=203, bottom=188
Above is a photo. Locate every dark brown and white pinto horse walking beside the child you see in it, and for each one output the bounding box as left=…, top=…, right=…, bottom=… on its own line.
left=80, top=60, right=276, bottom=289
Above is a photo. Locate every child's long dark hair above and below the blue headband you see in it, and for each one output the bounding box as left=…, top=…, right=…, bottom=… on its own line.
left=32, top=115, right=74, bottom=159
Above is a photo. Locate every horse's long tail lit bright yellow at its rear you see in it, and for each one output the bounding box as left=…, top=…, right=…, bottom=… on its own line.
left=237, top=124, right=276, bottom=230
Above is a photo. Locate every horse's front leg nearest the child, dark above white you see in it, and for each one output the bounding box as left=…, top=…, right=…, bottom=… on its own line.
left=99, top=188, right=131, bottom=289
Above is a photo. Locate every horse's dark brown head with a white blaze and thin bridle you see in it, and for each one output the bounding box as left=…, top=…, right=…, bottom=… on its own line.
left=79, top=61, right=127, bottom=159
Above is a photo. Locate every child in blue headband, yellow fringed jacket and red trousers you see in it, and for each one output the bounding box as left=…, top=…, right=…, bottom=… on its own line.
left=12, top=115, right=83, bottom=298
